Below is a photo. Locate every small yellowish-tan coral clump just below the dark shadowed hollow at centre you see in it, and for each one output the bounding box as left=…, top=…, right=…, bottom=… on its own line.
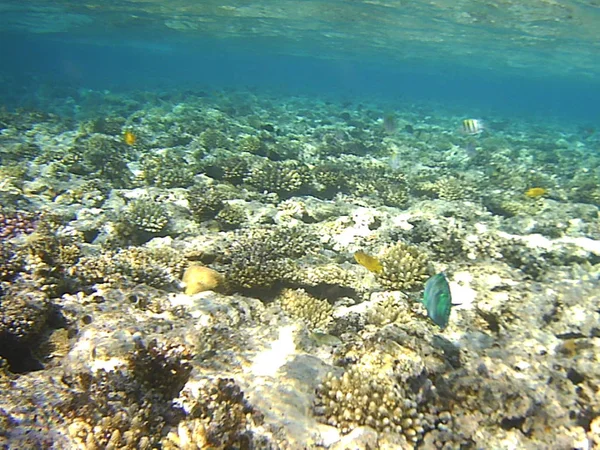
left=275, top=289, right=333, bottom=331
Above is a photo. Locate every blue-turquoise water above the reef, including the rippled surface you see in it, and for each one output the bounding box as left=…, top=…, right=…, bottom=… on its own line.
left=0, top=1, right=600, bottom=124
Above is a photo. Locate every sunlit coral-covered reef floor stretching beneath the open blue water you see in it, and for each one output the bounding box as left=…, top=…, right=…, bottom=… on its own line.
left=0, top=86, right=600, bottom=450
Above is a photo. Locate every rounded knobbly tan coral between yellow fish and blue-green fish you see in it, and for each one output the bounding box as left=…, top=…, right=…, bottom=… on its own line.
left=375, top=242, right=429, bottom=291
